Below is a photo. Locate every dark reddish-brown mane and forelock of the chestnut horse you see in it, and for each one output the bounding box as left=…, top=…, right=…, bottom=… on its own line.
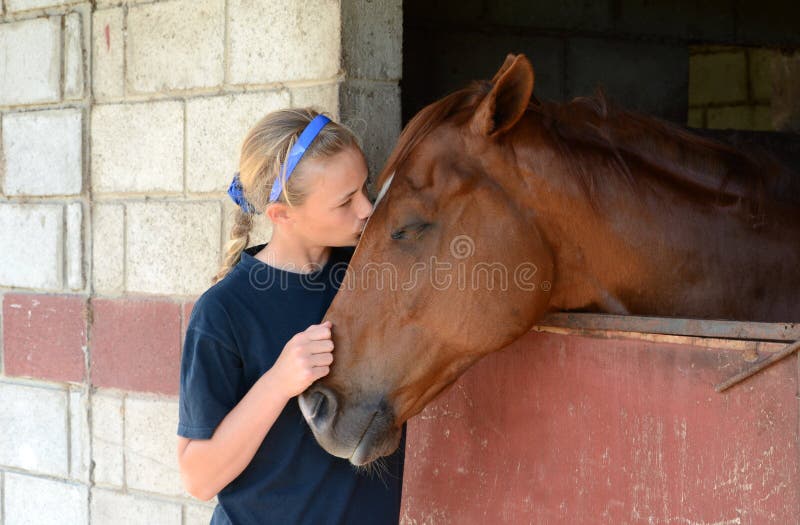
left=377, top=81, right=800, bottom=226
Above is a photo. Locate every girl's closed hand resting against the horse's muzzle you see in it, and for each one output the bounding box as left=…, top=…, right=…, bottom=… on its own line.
left=270, top=321, right=333, bottom=397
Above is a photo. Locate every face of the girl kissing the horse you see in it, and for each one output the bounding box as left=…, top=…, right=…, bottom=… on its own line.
left=292, top=147, right=372, bottom=246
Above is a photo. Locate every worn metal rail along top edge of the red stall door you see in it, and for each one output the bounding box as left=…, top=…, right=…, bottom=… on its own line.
left=537, top=312, right=800, bottom=342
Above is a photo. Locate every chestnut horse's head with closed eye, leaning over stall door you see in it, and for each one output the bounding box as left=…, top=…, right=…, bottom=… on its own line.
left=300, top=55, right=553, bottom=464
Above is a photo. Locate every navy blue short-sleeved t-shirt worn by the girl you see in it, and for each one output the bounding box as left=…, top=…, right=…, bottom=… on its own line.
left=178, top=244, right=406, bottom=525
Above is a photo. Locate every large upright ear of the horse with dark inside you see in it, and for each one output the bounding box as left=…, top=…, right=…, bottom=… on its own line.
left=470, top=54, right=533, bottom=137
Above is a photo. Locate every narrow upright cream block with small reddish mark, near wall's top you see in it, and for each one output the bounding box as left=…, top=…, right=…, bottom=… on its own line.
left=92, top=8, right=125, bottom=101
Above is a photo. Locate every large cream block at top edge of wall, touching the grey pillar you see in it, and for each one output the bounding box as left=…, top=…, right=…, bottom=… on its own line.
left=228, top=0, right=341, bottom=84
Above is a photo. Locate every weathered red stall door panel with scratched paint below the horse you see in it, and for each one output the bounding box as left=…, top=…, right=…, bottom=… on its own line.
left=402, top=332, right=800, bottom=525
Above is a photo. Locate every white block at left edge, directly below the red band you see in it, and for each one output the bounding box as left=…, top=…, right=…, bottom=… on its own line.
left=0, top=383, right=69, bottom=474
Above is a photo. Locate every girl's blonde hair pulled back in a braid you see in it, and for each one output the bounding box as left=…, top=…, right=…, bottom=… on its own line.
left=211, top=108, right=359, bottom=284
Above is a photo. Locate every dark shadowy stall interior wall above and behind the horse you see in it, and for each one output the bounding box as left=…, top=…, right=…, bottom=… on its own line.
left=402, top=0, right=800, bottom=124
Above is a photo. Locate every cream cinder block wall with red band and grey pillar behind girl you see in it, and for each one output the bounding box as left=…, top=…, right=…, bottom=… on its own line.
left=0, top=0, right=402, bottom=525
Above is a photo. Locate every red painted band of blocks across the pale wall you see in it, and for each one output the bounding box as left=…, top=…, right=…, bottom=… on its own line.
left=2, top=293, right=189, bottom=395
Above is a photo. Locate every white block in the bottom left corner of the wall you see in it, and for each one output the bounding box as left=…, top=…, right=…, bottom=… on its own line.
left=4, top=472, right=89, bottom=525
